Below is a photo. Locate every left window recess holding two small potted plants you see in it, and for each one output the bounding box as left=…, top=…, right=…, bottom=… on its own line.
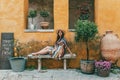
left=27, top=0, right=54, bottom=31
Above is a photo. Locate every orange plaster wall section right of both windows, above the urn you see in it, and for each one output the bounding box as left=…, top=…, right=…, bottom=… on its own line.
left=95, top=0, right=120, bottom=36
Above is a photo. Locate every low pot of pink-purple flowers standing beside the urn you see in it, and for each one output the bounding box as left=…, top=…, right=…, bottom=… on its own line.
left=95, top=61, right=111, bottom=77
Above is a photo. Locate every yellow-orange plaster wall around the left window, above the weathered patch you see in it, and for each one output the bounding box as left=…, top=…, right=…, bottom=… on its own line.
left=0, top=0, right=73, bottom=41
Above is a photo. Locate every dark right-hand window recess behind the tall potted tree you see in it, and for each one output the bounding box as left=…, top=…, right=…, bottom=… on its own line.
left=69, top=0, right=94, bottom=29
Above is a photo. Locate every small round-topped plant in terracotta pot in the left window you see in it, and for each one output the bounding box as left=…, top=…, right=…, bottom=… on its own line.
left=40, top=10, right=49, bottom=29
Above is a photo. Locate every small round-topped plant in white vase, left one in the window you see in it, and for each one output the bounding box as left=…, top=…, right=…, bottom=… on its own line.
left=28, top=10, right=37, bottom=29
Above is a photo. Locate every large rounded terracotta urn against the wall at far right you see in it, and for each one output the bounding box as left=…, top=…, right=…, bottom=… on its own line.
left=101, top=30, right=120, bottom=63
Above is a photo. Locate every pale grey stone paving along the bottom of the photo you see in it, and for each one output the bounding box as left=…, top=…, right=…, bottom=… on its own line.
left=0, top=69, right=120, bottom=80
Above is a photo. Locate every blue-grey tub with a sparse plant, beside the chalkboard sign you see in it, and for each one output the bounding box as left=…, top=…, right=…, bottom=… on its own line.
left=9, top=40, right=27, bottom=72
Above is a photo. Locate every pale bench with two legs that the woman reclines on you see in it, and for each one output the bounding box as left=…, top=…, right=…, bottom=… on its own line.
left=29, top=54, right=76, bottom=71
